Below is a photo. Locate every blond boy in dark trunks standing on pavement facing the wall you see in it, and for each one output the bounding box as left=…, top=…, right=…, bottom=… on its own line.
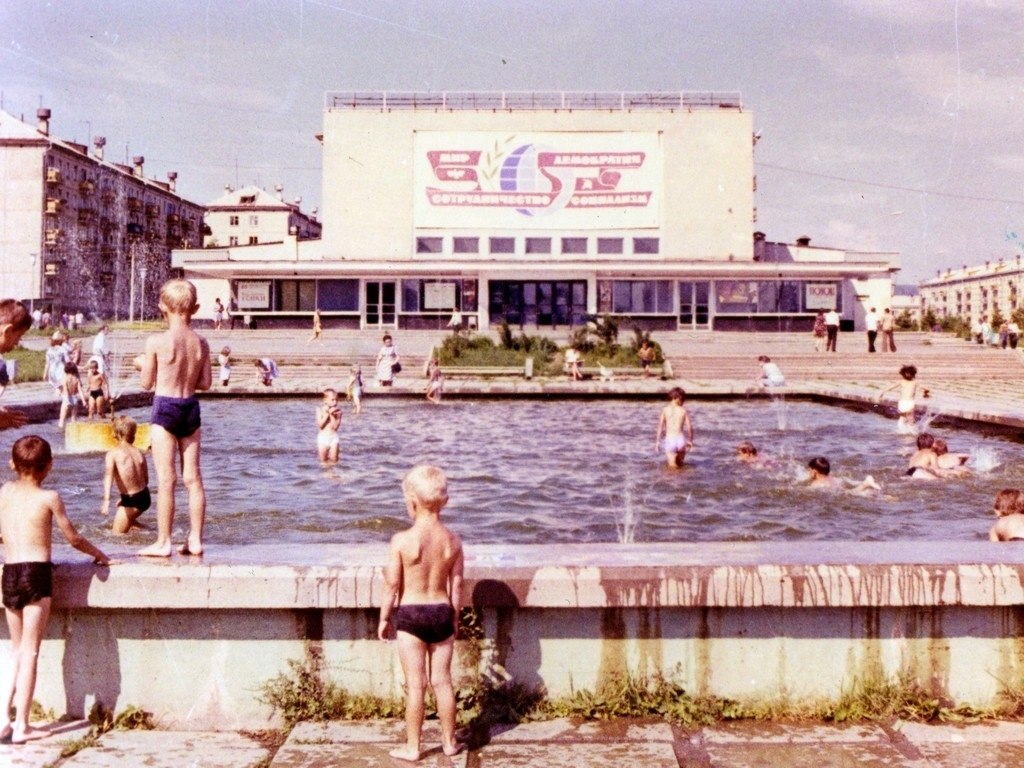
left=377, top=465, right=464, bottom=761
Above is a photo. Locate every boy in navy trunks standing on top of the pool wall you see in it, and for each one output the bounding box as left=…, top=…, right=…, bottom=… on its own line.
left=135, top=280, right=213, bottom=557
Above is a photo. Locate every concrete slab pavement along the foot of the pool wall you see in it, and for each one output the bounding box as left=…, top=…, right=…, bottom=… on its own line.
left=6, top=719, right=1024, bottom=768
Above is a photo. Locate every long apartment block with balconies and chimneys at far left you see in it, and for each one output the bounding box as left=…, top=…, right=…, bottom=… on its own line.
left=0, top=109, right=203, bottom=318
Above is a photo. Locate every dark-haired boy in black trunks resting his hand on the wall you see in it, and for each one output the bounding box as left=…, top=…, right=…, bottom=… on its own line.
left=0, top=435, right=111, bottom=744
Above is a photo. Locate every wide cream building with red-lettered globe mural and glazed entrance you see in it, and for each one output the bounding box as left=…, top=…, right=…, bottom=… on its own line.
left=174, top=92, right=898, bottom=331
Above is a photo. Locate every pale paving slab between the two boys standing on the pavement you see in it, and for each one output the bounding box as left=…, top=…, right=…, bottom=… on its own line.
left=60, top=731, right=269, bottom=768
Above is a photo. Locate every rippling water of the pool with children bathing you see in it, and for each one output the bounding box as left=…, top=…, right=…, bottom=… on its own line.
left=14, top=398, right=1024, bottom=546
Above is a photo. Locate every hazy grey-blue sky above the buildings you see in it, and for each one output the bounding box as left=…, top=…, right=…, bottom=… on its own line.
left=0, top=0, right=1024, bottom=284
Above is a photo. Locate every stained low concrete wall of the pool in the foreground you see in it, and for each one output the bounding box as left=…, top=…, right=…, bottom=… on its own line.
left=5, top=542, right=1024, bottom=729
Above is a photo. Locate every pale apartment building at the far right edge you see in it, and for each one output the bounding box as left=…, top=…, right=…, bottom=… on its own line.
left=921, top=255, right=1024, bottom=323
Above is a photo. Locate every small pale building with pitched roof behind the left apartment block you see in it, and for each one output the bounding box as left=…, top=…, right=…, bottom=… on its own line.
left=203, top=184, right=322, bottom=248
